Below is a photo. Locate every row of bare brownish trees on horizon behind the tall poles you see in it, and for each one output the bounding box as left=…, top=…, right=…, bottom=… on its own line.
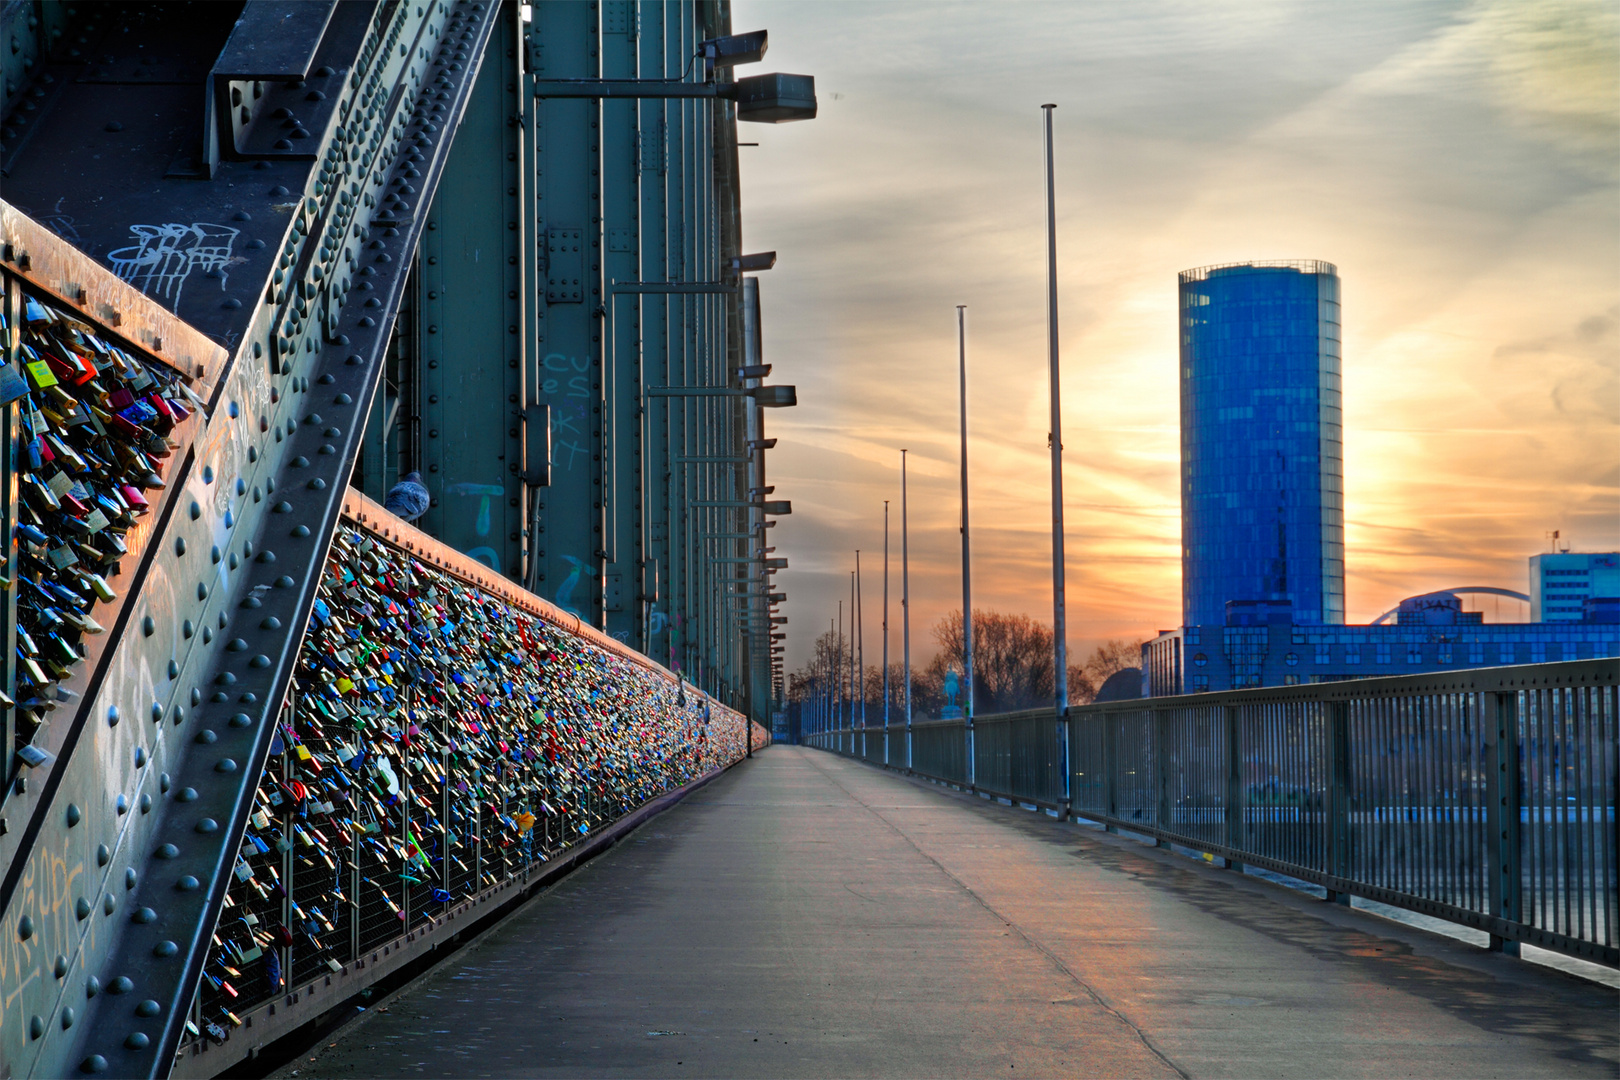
left=787, top=609, right=1142, bottom=724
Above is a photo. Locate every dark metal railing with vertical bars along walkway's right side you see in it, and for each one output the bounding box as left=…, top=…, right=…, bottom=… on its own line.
left=805, top=659, right=1620, bottom=967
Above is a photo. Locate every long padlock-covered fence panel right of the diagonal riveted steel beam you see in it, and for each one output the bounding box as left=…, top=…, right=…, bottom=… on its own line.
left=194, top=529, right=748, bottom=1040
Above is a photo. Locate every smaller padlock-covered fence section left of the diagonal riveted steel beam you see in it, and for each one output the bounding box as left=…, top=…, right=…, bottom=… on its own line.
left=0, top=283, right=201, bottom=764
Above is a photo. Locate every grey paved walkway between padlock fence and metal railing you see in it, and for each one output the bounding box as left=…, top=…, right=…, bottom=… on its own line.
left=279, top=746, right=1620, bottom=1080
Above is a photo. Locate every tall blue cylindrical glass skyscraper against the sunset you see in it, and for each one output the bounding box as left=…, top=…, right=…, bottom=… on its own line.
left=1179, top=261, right=1345, bottom=627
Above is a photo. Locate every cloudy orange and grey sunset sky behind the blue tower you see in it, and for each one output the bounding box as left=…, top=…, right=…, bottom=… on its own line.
left=734, top=0, right=1620, bottom=669
